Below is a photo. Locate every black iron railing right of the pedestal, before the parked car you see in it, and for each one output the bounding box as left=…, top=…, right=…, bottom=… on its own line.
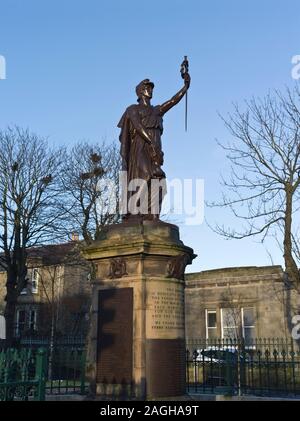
left=186, top=338, right=300, bottom=396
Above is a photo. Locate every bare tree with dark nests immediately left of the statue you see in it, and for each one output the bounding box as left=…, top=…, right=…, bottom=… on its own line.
left=62, top=142, right=120, bottom=244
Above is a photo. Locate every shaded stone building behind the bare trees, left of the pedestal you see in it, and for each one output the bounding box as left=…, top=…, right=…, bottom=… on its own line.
left=0, top=242, right=90, bottom=338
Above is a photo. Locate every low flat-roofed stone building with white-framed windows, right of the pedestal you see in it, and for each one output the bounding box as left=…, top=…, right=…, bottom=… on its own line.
left=185, top=266, right=300, bottom=342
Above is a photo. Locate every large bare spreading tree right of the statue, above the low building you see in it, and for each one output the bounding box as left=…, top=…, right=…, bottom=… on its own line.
left=209, top=87, right=300, bottom=289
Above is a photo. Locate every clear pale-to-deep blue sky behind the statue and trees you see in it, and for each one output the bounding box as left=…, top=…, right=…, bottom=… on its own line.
left=0, top=0, right=300, bottom=271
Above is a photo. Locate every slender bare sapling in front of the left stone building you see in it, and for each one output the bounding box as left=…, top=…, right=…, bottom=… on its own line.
left=36, top=242, right=90, bottom=379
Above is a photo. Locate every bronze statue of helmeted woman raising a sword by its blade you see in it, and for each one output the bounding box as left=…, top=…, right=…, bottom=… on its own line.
left=118, top=58, right=190, bottom=219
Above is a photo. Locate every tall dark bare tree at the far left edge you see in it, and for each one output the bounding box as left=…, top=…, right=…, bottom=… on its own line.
left=0, top=127, right=64, bottom=344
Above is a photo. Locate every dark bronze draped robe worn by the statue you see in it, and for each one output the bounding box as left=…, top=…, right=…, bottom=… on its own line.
left=118, top=104, right=166, bottom=217
